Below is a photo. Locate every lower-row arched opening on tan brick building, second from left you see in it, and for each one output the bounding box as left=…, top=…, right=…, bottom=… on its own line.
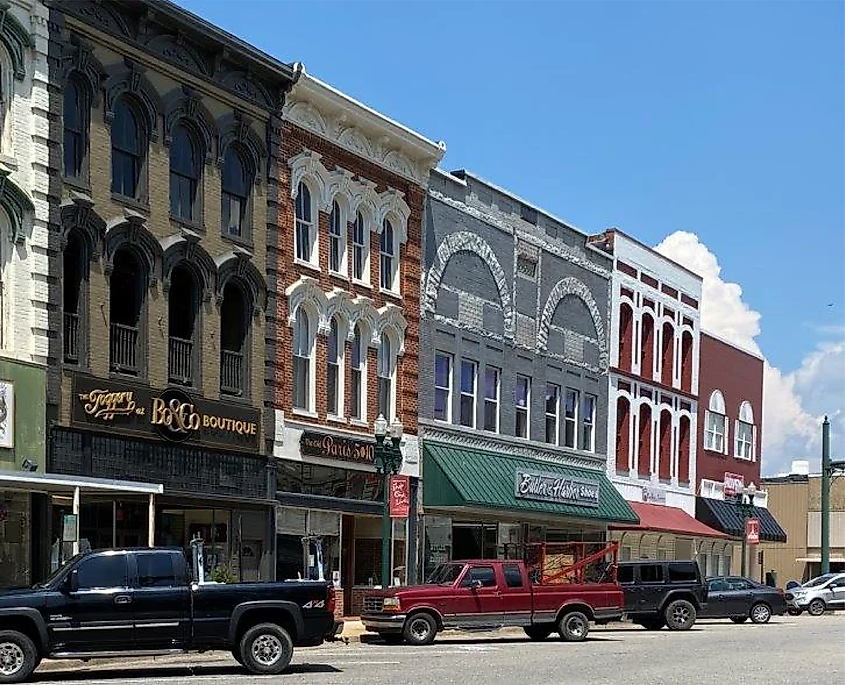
left=109, top=248, right=146, bottom=375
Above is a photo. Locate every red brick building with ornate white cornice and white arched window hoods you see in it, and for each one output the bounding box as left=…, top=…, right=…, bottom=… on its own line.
left=267, top=72, right=444, bottom=612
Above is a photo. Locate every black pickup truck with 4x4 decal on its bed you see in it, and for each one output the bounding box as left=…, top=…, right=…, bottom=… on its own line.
left=0, top=548, right=336, bottom=683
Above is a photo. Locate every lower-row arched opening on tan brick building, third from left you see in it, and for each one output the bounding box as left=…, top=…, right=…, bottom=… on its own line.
left=167, top=262, right=200, bottom=385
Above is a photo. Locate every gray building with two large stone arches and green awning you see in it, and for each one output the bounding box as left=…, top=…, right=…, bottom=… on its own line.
left=419, top=171, right=636, bottom=573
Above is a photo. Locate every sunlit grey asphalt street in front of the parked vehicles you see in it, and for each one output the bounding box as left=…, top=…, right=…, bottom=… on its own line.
left=36, top=614, right=845, bottom=685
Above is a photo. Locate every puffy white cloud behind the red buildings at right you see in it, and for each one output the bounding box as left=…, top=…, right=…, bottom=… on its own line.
left=655, top=231, right=845, bottom=475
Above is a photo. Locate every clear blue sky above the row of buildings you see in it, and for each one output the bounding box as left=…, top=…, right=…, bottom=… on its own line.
left=175, top=0, right=845, bottom=468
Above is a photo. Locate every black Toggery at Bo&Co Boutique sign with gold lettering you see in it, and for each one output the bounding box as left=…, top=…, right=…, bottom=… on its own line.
left=72, top=374, right=259, bottom=451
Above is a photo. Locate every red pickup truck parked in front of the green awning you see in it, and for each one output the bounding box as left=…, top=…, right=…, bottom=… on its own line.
left=361, top=559, right=624, bottom=645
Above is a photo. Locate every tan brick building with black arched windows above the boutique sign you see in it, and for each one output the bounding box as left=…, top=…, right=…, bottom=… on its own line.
left=48, top=0, right=295, bottom=578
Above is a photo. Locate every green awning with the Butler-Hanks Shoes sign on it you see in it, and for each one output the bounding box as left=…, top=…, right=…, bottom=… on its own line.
left=423, top=441, right=639, bottom=523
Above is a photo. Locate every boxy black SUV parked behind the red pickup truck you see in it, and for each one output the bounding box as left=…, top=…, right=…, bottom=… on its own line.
left=617, top=560, right=707, bottom=630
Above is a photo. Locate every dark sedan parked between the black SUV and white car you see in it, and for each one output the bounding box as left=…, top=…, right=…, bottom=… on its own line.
left=699, top=576, right=786, bottom=623
